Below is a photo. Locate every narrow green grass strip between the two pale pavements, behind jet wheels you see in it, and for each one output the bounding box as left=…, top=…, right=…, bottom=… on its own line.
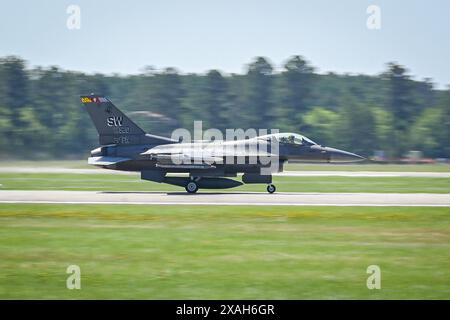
left=0, top=173, right=450, bottom=193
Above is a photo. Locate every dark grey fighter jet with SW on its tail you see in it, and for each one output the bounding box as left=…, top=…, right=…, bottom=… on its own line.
left=81, top=94, right=364, bottom=193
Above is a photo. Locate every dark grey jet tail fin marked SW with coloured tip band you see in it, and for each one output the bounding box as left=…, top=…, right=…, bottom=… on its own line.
left=81, top=94, right=145, bottom=145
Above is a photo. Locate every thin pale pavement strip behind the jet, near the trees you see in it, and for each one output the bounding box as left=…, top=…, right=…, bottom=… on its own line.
left=0, top=167, right=450, bottom=178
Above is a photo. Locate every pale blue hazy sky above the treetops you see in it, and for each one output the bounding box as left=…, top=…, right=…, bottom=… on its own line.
left=0, top=0, right=450, bottom=89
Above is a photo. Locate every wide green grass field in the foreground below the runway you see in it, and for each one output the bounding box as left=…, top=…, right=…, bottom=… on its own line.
left=0, top=204, right=450, bottom=299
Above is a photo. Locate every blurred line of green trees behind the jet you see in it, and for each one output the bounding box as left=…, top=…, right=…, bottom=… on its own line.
left=0, top=56, right=450, bottom=159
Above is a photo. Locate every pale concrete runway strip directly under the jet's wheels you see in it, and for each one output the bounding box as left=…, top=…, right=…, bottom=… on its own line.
left=0, top=190, right=450, bottom=207
